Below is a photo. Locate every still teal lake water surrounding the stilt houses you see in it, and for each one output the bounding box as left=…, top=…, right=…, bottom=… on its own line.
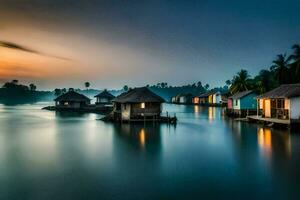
left=0, top=104, right=300, bottom=200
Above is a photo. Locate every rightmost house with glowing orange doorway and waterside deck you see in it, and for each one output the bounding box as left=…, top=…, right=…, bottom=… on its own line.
left=253, top=84, right=300, bottom=124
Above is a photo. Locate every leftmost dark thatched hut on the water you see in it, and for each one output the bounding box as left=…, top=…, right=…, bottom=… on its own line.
left=54, top=91, right=91, bottom=109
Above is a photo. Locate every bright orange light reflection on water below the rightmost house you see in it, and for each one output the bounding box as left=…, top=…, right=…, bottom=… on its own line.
left=257, top=128, right=272, bottom=157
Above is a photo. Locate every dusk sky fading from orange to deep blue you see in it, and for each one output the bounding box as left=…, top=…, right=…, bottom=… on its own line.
left=0, top=0, right=300, bottom=89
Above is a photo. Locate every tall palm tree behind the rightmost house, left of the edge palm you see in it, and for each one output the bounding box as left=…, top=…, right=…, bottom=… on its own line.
left=271, top=54, right=291, bottom=85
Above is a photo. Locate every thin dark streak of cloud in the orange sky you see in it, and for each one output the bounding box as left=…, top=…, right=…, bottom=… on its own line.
left=0, top=40, right=71, bottom=60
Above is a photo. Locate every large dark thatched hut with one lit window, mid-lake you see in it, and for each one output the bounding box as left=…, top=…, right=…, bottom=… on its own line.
left=113, top=87, right=165, bottom=121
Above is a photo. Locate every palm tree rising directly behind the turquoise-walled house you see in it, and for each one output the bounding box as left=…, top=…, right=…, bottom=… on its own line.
left=230, top=69, right=250, bottom=94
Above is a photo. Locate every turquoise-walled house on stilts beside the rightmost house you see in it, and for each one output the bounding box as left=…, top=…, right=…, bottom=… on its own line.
left=227, top=90, right=257, bottom=117
